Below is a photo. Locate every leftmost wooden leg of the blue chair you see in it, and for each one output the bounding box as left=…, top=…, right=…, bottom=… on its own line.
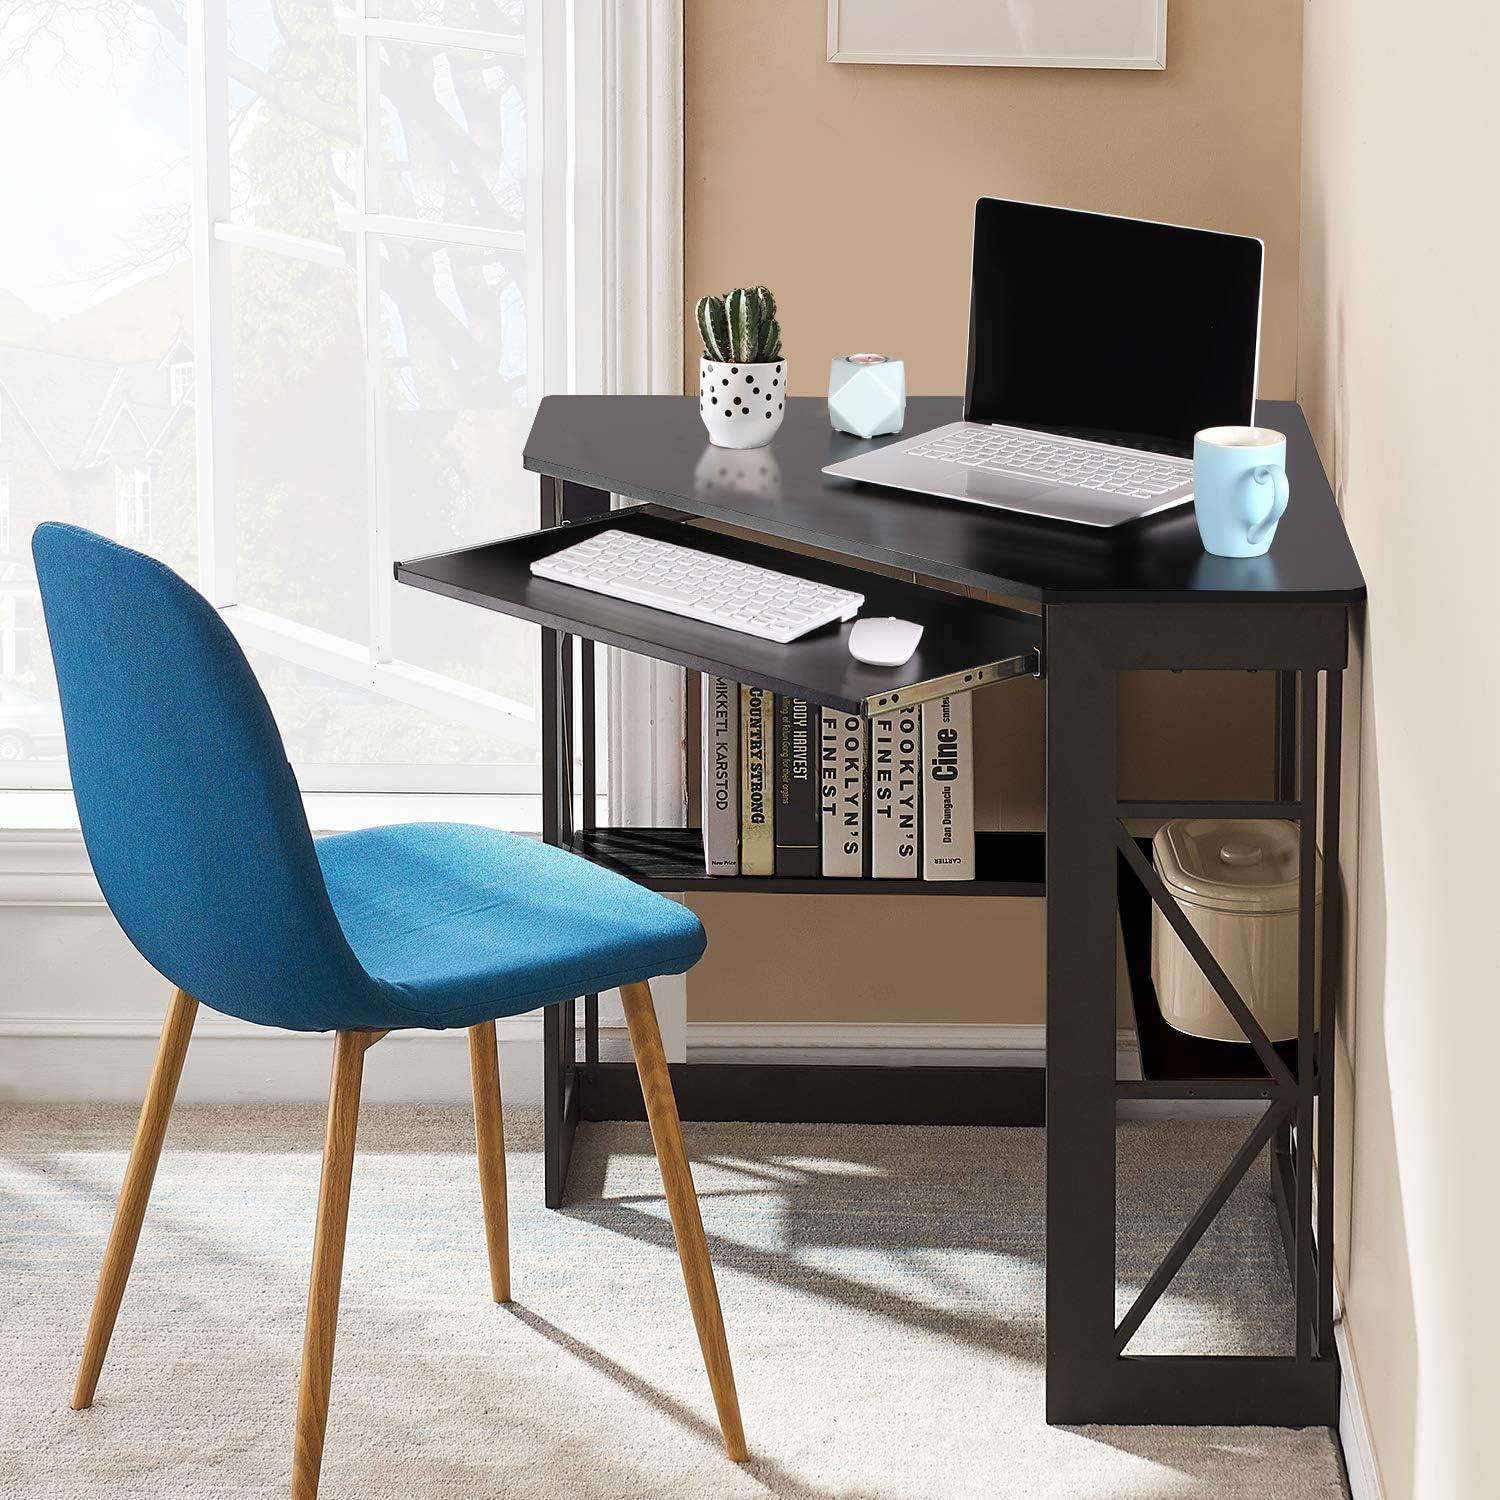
left=72, top=990, right=198, bottom=1412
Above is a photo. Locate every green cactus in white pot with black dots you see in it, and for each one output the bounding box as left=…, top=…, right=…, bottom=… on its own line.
left=698, top=287, right=786, bottom=449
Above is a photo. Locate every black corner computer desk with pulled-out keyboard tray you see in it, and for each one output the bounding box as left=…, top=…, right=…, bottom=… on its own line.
left=396, top=396, right=1365, bottom=1427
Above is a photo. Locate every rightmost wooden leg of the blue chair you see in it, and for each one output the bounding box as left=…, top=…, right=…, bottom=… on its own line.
left=620, top=983, right=749, bottom=1464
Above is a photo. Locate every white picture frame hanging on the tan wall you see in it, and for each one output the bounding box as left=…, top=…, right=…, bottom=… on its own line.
left=828, top=0, right=1167, bottom=69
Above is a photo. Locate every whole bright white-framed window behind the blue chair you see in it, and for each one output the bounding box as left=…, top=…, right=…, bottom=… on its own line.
left=0, top=0, right=618, bottom=794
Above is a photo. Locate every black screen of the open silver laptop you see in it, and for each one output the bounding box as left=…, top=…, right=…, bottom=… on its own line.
left=965, top=198, right=1262, bottom=458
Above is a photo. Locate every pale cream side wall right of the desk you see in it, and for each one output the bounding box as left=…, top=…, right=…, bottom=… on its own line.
left=1299, top=0, right=1500, bottom=1500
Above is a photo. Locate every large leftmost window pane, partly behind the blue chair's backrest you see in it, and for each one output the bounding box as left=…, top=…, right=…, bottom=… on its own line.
left=0, top=5, right=197, bottom=786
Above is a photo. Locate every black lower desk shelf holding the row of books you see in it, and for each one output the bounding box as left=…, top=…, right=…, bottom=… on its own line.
left=572, top=828, right=1047, bottom=896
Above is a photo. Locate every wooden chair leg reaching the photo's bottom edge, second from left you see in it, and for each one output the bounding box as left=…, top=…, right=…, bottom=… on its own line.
left=291, top=1032, right=386, bottom=1500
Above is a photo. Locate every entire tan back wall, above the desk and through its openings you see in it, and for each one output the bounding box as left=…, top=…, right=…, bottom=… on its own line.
left=684, top=0, right=1302, bottom=1022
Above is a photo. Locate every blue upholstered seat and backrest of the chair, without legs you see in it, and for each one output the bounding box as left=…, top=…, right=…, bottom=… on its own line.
left=32, top=524, right=705, bottom=1031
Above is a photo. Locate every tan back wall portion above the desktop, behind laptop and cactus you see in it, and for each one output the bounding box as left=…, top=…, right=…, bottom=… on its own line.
left=684, top=0, right=1302, bottom=396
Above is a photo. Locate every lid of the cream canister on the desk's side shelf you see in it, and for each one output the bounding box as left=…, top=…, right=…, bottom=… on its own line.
left=1152, top=818, right=1323, bottom=912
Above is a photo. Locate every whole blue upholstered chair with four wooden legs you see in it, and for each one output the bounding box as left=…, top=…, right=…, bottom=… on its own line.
left=32, top=524, right=746, bottom=1500
